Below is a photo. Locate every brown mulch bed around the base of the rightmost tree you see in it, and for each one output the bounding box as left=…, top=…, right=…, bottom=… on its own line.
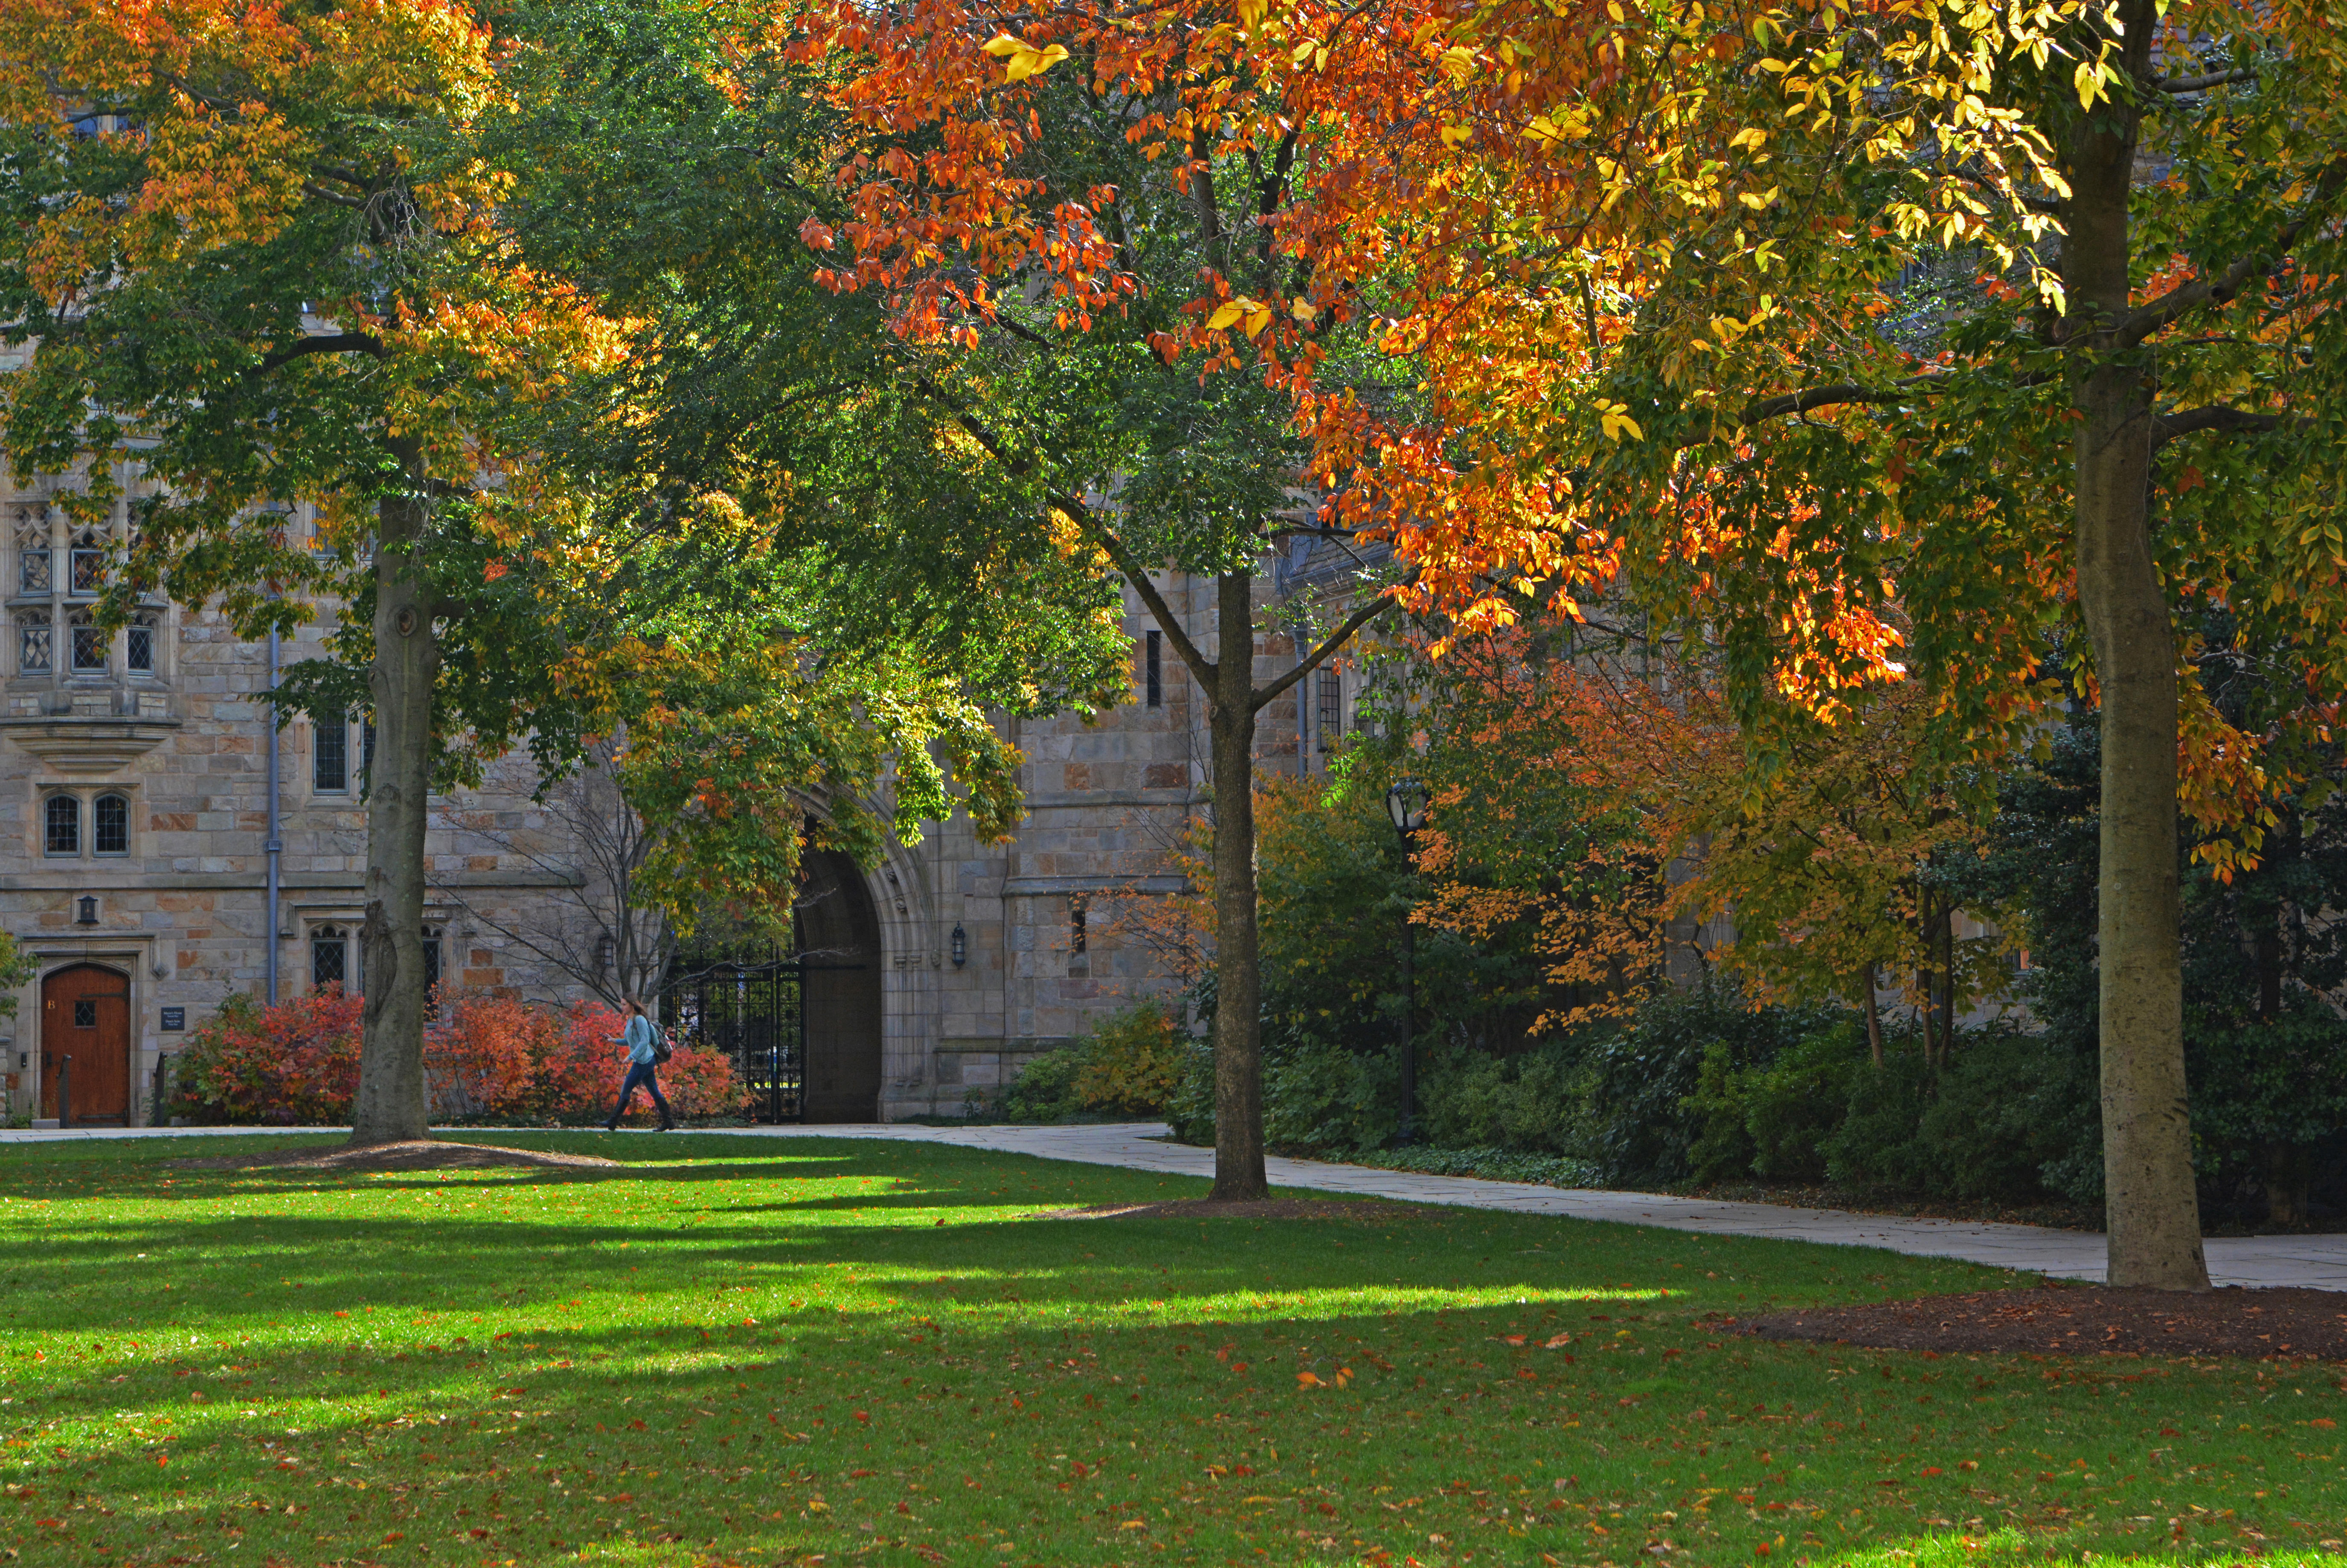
left=1734, top=1284, right=2347, bottom=1362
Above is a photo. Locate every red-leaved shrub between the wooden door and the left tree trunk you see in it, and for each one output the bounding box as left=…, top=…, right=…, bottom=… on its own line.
left=171, top=986, right=361, bottom=1124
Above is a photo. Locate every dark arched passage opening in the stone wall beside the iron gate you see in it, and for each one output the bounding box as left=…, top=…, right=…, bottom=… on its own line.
left=796, top=850, right=880, bottom=1122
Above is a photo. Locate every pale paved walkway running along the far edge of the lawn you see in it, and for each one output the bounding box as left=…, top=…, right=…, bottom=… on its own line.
left=0, top=1122, right=2347, bottom=1291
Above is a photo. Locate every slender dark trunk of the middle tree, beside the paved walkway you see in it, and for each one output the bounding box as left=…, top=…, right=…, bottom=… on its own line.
left=1209, top=573, right=1270, bottom=1202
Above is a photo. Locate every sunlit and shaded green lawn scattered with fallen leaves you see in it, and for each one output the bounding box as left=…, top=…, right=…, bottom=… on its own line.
left=0, top=1134, right=2347, bottom=1568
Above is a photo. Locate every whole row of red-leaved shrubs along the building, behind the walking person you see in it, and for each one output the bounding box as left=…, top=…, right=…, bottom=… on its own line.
left=171, top=986, right=751, bottom=1122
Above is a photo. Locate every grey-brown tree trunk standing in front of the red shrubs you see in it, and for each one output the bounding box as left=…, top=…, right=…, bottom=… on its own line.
left=350, top=453, right=439, bottom=1143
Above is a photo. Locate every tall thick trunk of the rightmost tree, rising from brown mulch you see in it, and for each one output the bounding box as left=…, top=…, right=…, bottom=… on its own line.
left=2063, top=0, right=2208, bottom=1291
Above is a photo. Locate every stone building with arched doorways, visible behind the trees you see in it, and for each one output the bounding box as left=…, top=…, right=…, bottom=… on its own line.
left=0, top=460, right=1354, bottom=1124
